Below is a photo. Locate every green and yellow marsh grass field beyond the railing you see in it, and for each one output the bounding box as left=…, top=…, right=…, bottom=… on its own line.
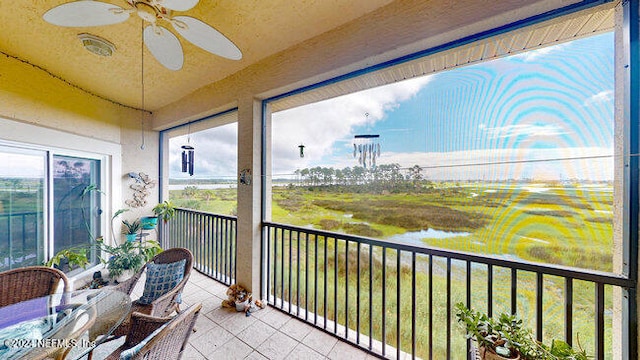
left=171, top=183, right=613, bottom=358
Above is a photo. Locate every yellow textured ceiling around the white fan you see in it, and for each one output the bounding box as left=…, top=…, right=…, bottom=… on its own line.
left=0, top=0, right=392, bottom=111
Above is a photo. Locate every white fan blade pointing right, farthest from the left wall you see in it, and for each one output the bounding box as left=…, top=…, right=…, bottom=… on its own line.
left=171, top=16, right=242, bottom=60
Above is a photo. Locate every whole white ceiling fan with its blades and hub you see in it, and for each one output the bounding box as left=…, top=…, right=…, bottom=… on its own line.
left=42, top=0, right=242, bottom=70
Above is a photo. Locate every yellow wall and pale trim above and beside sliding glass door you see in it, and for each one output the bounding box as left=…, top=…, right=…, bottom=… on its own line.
left=0, top=52, right=158, bottom=245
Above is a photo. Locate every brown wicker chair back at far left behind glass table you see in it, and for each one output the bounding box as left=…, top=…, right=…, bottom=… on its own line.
left=0, top=266, right=70, bottom=307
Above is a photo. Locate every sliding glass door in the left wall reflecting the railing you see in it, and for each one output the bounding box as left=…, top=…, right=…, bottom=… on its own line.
left=0, top=145, right=102, bottom=271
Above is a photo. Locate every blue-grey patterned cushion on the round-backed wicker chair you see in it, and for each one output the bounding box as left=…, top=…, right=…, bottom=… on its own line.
left=138, top=260, right=186, bottom=305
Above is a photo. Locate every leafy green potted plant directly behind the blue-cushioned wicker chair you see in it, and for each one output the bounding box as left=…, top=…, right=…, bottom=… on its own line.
left=98, top=240, right=162, bottom=282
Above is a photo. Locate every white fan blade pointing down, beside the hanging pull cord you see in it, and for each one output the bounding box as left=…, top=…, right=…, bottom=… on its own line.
left=143, top=25, right=184, bottom=70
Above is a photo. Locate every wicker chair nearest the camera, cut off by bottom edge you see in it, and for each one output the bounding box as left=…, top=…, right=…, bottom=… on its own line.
left=106, top=304, right=202, bottom=360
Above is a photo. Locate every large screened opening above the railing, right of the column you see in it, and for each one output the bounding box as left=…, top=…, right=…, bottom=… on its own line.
left=271, top=32, right=615, bottom=272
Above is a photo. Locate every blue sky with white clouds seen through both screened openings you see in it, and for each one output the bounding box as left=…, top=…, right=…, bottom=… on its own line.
left=170, top=33, right=614, bottom=181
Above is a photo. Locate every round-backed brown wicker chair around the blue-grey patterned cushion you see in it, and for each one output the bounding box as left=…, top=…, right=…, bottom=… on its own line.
left=113, top=248, right=193, bottom=337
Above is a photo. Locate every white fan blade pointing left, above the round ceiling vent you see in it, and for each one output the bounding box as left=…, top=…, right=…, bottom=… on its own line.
left=42, top=0, right=129, bottom=27
